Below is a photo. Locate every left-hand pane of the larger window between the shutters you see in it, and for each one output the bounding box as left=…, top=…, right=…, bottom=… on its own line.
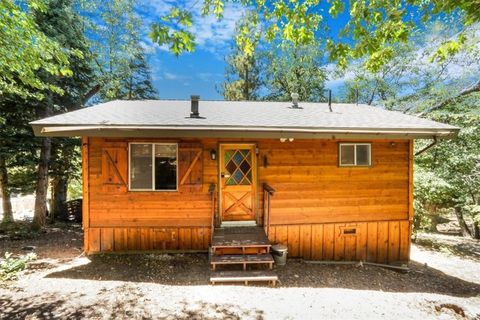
left=130, top=144, right=152, bottom=189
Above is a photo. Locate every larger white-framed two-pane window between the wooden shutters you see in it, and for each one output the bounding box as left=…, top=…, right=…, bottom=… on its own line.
left=129, top=142, right=178, bottom=191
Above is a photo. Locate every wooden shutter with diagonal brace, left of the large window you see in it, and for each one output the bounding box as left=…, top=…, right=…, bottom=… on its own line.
left=102, top=147, right=128, bottom=191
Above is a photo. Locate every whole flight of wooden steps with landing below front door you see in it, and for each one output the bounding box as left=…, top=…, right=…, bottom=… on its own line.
left=210, top=227, right=278, bottom=285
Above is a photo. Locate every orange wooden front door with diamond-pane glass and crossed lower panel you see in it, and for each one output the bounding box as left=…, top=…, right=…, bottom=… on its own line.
left=219, top=144, right=257, bottom=221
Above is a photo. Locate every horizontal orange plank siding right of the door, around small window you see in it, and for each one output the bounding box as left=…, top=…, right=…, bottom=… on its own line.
left=258, top=140, right=410, bottom=225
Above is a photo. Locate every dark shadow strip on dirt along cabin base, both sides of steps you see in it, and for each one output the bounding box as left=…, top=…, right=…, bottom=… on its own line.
left=47, top=254, right=480, bottom=297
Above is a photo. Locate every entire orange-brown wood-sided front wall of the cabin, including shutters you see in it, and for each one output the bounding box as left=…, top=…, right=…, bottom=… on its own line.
left=82, top=138, right=413, bottom=262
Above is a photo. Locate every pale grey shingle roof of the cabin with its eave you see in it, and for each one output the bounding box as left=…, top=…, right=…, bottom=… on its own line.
left=31, top=100, right=458, bottom=136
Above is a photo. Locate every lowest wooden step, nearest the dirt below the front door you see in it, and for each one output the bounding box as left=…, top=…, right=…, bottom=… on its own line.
left=210, top=270, right=278, bottom=286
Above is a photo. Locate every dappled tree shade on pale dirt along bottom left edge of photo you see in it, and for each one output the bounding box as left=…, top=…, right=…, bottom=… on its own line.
left=0, top=284, right=263, bottom=320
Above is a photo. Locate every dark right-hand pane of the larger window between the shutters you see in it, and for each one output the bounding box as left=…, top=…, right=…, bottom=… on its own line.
left=155, top=144, right=177, bottom=190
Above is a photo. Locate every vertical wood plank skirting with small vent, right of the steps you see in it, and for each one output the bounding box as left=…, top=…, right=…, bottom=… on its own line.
left=268, top=220, right=411, bottom=263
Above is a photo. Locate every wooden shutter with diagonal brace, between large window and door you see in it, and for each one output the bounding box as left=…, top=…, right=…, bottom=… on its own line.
left=178, top=143, right=203, bottom=191
